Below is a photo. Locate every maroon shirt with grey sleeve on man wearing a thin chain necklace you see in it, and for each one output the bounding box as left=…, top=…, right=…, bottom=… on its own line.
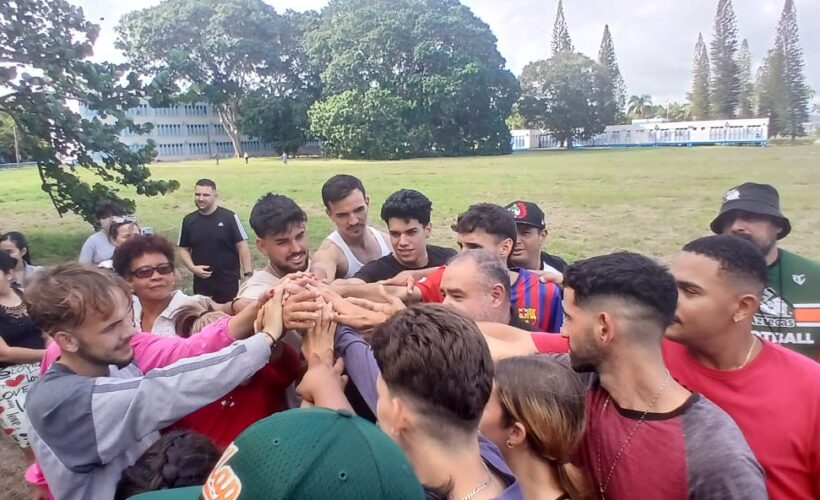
left=558, top=355, right=768, bottom=499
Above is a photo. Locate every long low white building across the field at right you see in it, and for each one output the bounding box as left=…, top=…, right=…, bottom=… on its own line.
left=510, top=118, right=769, bottom=151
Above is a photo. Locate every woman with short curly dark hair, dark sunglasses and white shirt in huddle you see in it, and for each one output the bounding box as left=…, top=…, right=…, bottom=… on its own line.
left=112, top=235, right=228, bottom=336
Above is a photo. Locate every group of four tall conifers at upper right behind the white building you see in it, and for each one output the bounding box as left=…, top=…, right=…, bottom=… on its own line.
left=689, top=0, right=811, bottom=138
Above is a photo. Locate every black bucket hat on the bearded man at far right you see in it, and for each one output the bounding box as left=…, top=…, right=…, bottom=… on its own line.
left=709, top=182, right=792, bottom=240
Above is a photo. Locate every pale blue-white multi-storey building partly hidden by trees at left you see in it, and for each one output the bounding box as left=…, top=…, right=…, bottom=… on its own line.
left=80, top=103, right=319, bottom=161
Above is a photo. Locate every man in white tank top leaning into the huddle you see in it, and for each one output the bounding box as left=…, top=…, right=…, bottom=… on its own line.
left=310, top=174, right=393, bottom=281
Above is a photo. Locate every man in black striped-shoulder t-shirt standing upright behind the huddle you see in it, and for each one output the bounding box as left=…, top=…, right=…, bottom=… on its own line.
left=179, top=179, right=253, bottom=303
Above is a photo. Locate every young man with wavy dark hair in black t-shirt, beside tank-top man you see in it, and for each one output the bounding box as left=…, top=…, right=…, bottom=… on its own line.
left=353, top=189, right=456, bottom=283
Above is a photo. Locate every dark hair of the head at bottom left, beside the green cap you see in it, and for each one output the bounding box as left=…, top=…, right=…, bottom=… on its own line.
left=114, top=430, right=222, bottom=500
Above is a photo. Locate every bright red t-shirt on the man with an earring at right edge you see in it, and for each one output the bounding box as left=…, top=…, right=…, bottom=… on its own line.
left=663, top=340, right=820, bottom=500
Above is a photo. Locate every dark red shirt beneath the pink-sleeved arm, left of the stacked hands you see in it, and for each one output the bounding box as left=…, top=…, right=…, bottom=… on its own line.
left=169, top=345, right=300, bottom=449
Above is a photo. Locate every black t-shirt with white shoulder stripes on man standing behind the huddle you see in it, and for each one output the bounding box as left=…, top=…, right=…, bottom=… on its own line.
left=179, top=207, right=248, bottom=281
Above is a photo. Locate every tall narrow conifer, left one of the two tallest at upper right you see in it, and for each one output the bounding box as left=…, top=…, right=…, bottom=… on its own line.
left=709, top=0, right=740, bottom=118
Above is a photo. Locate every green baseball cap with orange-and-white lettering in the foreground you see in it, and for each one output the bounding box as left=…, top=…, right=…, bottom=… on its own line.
left=131, top=408, right=424, bottom=500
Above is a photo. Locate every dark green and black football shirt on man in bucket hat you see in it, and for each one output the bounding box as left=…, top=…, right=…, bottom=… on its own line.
left=752, top=250, right=820, bottom=361
